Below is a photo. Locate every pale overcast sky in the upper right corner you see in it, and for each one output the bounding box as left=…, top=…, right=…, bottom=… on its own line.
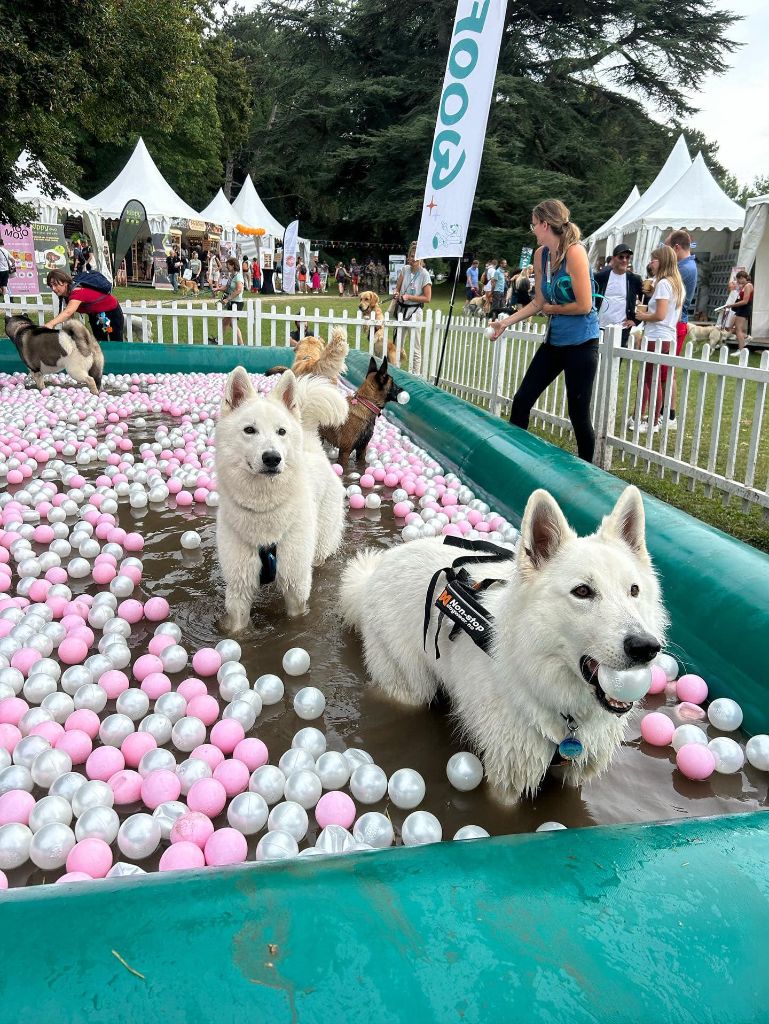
left=690, top=0, right=769, bottom=184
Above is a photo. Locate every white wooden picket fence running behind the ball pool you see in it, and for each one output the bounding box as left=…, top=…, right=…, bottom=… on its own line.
left=6, top=298, right=769, bottom=519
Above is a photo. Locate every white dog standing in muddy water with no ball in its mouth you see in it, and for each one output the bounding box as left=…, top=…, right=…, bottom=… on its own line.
left=216, top=367, right=347, bottom=632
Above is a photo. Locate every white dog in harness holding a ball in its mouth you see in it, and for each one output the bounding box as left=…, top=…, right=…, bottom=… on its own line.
left=341, top=486, right=667, bottom=803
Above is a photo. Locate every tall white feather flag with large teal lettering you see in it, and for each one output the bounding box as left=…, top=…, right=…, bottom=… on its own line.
left=417, top=0, right=507, bottom=259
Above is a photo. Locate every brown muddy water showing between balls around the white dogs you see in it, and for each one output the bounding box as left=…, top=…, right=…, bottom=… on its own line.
left=7, top=409, right=769, bottom=886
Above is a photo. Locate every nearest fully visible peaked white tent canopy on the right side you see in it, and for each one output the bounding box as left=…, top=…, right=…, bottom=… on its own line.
left=623, top=153, right=744, bottom=266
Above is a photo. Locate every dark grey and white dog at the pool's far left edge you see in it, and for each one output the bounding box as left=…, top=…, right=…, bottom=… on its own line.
left=5, top=316, right=104, bottom=394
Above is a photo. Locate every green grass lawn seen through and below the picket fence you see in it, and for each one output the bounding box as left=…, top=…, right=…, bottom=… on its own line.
left=109, top=283, right=769, bottom=552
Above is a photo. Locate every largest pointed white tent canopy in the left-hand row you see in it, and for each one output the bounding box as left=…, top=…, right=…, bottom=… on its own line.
left=91, top=138, right=205, bottom=232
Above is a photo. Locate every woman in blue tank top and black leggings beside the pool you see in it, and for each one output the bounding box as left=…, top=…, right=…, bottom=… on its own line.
left=492, top=199, right=598, bottom=462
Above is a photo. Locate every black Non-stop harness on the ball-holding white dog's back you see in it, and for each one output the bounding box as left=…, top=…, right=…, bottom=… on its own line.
left=422, top=537, right=515, bottom=660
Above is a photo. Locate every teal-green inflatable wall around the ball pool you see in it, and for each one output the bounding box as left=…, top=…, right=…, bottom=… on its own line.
left=0, top=343, right=769, bottom=1024
